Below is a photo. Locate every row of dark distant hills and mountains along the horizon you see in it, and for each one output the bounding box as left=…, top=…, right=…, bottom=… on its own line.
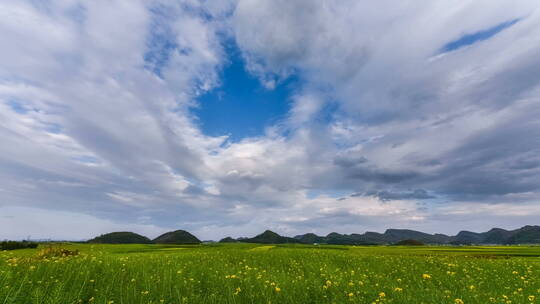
left=88, top=226, right=540, bottom=245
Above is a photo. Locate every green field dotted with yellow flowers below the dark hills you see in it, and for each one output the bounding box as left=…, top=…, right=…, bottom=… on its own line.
left=0, top=244, right=540, bottom=304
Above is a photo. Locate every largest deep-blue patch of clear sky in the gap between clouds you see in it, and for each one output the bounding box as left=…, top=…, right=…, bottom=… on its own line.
left=193, top=42, right=299, bottom=141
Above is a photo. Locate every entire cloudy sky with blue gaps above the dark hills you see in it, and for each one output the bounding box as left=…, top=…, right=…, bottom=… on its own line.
left=0, top=0, right=540, bottom=240
